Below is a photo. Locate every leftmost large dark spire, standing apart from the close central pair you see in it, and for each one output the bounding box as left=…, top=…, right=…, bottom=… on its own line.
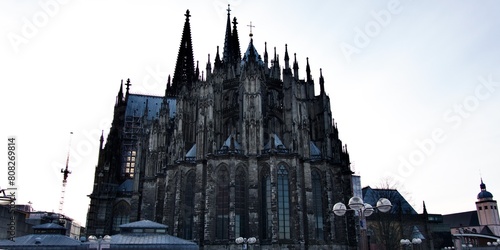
left=172, top=10, right=195, bottom=93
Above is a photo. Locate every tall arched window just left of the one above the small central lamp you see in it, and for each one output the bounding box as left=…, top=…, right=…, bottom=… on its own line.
left=215, top=168, right=229, bottom=240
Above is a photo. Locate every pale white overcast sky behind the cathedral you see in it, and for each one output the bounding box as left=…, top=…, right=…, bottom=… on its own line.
left=0, top=0, right=500, bottom=225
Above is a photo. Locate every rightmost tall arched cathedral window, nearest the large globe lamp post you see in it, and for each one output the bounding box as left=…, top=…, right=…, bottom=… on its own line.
left=311, top=169, right=325, bottom=240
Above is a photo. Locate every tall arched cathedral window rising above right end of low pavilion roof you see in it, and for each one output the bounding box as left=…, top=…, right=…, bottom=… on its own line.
left=183, top=171, right=196, bottom=240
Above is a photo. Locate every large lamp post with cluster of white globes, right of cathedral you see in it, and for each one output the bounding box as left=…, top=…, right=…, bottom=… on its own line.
left=333, top=196, right=392, bottom=250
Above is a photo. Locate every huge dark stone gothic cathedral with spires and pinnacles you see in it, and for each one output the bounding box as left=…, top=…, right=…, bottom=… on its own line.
left=87, top=9, right=357, bottom=249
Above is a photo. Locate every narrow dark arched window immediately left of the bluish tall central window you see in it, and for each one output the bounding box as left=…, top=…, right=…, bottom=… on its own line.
left=260, top=169, right=273, bottom=239
